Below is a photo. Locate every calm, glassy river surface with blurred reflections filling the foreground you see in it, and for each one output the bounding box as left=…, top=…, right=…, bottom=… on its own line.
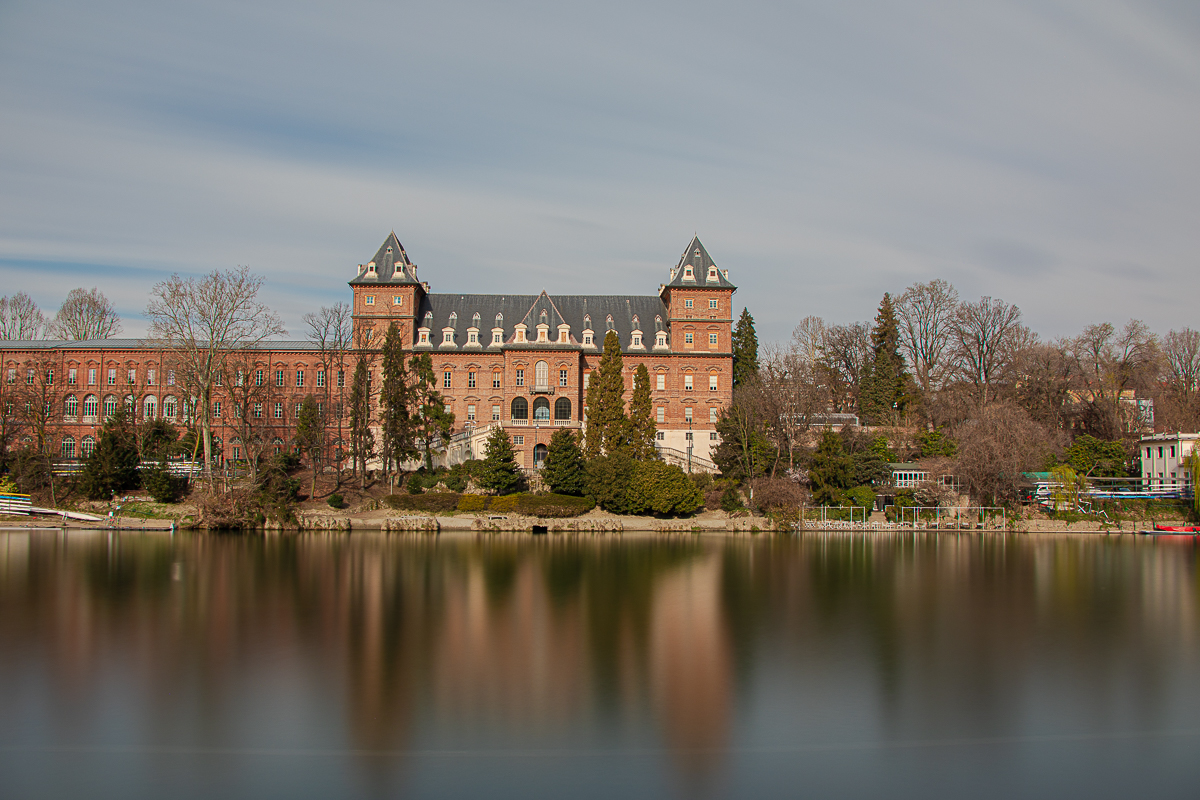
left=0, top=531, right=1200, bottom=799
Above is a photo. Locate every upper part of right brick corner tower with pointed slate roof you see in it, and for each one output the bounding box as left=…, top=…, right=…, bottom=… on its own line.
left=659, top=236, right=737, bottom=354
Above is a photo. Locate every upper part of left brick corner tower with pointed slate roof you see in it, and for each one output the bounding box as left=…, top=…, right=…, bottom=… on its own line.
left=350, top=230, right=428, bottom=347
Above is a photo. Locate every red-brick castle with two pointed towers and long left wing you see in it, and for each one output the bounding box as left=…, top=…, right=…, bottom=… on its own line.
left=0, top=233, right=736, bottom=468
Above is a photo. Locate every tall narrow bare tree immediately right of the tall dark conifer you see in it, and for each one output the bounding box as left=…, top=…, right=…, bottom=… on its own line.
left=896, top=278, right=959, bottom=395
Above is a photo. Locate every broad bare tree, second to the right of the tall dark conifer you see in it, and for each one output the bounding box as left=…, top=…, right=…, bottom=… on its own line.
left=952, top=297, right=1032, bottom=405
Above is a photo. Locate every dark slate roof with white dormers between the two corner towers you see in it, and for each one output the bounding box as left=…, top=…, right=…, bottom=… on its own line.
left=416, top=291, right=670, bottom=351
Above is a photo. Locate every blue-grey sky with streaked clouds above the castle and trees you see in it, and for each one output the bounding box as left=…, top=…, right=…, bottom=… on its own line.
left=0, top=0, right=1200, bottom=341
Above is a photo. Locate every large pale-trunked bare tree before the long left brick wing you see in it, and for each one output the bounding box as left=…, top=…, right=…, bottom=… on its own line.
left=146, top=266, right=287, bottom=487
